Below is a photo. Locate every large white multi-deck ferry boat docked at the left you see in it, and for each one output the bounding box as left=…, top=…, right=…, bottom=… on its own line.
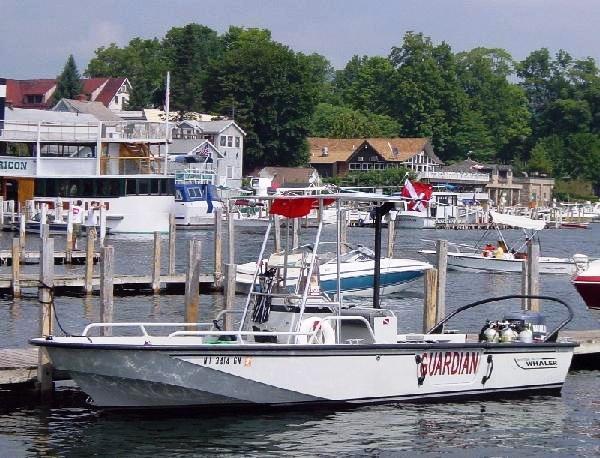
left=0, top=85, right=175, bottom=233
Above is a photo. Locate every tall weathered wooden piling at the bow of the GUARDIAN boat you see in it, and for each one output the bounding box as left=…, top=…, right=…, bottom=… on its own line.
left=37, top=238, right=54, bottom=397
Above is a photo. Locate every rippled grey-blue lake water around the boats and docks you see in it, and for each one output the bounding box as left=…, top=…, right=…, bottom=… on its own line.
left=0, top=225, right=600, bottom=456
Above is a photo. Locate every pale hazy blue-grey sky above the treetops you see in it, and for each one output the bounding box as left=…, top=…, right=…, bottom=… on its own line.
left=0, top=0, right=600, bottom=79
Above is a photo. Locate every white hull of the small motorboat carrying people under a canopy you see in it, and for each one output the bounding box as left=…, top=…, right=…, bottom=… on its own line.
left=419, top=250, right=576, bottom=275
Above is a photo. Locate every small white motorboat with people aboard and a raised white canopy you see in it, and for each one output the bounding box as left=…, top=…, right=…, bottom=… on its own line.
left=419, top=211, right=581, bottom=275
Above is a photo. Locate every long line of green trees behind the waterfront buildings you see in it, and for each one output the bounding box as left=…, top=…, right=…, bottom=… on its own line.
left=75, top=24, right=600, bottom=188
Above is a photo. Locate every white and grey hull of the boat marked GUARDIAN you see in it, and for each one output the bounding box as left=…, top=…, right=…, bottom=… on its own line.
left=32, top=339, right=573, bottom=408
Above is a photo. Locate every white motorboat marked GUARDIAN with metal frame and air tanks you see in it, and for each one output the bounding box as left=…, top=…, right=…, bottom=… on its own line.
left=31, top=195, right=575, bottom=412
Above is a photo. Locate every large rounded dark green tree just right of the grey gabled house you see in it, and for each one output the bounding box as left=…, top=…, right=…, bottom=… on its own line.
left=204, top=28, right=317, bottom=168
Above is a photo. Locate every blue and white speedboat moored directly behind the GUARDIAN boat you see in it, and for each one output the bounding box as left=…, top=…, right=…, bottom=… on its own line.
left=236, top=245, right=432, bottom=296
